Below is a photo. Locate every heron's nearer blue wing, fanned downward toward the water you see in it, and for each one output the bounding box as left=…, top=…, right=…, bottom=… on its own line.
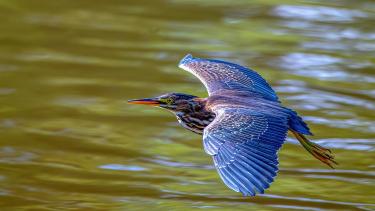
left=203, top=108, right=288, bottom=196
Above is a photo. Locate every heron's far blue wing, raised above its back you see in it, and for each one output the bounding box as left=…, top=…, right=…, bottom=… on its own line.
left=178, top=54, right=278, bottom=101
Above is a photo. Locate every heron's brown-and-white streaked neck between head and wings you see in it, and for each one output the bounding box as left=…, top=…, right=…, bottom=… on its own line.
left=176, top=98, right=215, bottom=134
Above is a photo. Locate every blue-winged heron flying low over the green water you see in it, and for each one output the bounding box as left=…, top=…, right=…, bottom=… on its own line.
left=128, top=54, right=338, bottom=196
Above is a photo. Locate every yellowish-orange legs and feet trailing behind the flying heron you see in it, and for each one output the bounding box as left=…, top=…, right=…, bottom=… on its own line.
left=290, top=130, right=338, bottom=168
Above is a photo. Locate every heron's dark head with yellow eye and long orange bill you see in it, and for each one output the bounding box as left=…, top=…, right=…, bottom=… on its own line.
left=128, top=93, right=198, bottom=112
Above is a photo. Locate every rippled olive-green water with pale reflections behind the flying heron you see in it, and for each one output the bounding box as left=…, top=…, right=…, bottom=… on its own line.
left=0, top=0, right=375, bottom=210
